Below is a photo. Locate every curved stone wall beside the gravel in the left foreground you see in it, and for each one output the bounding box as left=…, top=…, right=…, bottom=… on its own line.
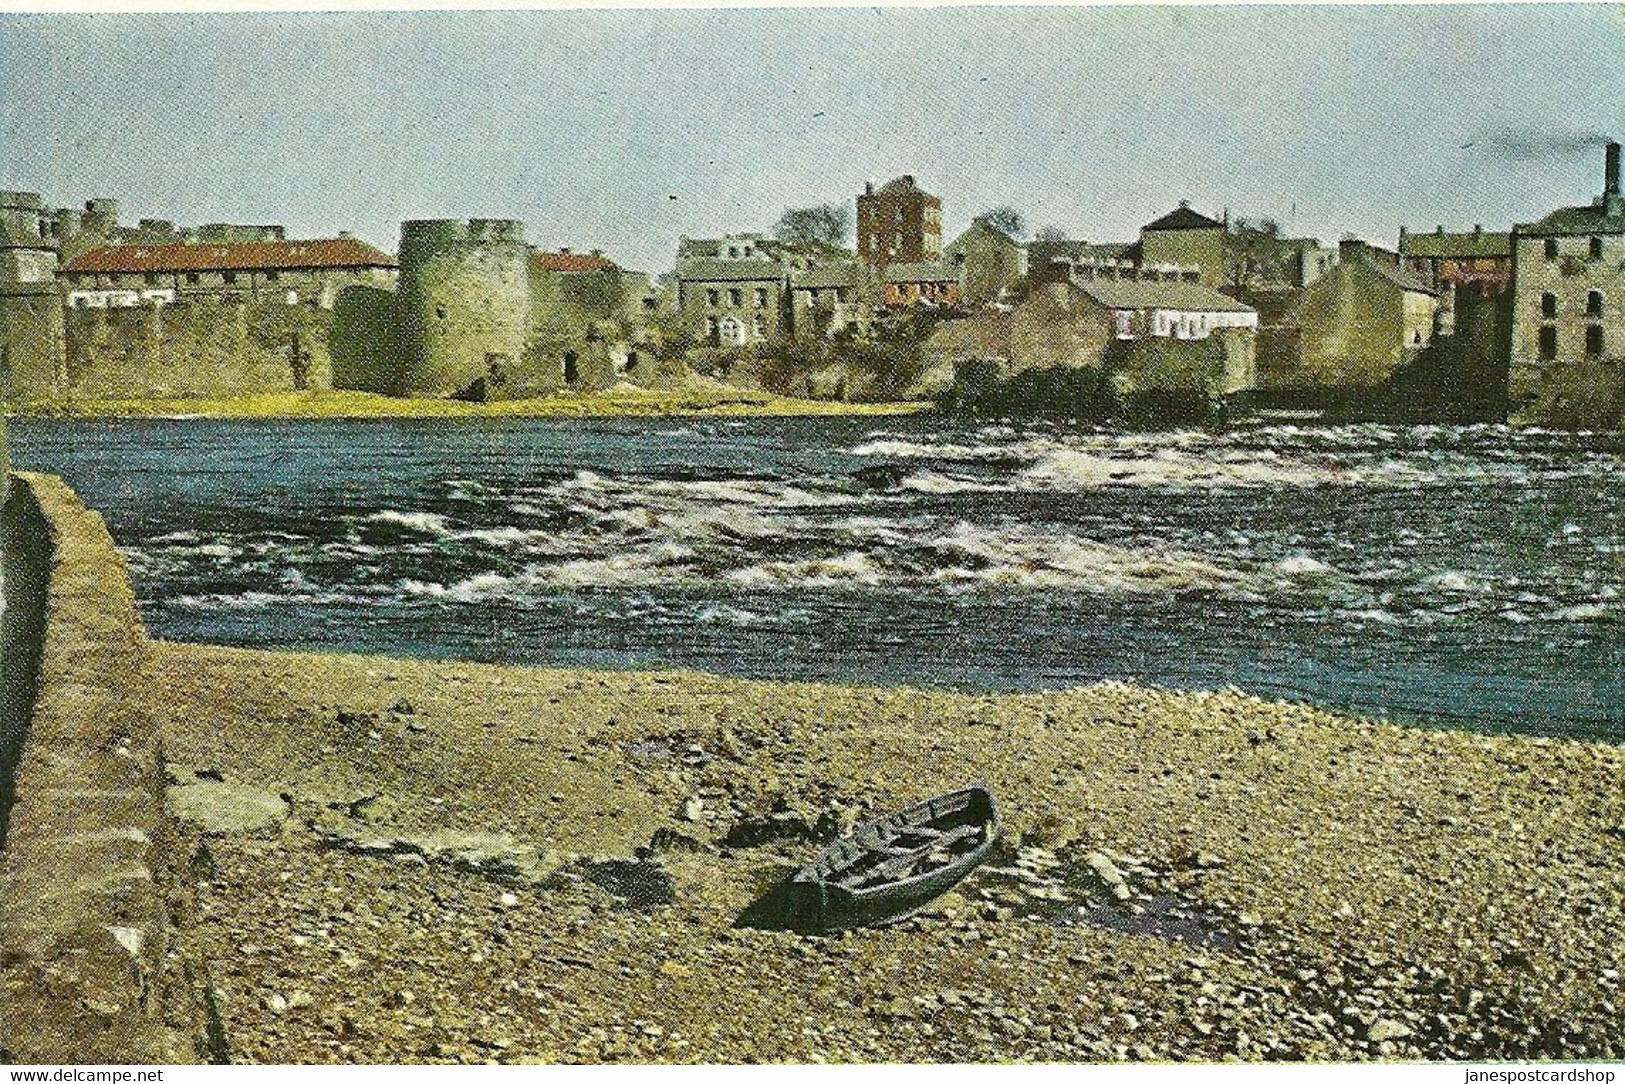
left=0, top=475, right=197, bottom=1063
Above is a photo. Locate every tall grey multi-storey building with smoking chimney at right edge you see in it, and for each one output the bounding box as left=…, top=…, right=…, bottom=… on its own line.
left=1508, top=143, right=1625, bottom=427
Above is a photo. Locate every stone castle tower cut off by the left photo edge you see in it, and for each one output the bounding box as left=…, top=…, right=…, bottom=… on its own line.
left=0, top=192, right=65, bottom=398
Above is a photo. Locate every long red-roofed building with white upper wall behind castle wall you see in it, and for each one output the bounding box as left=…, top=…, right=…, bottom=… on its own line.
left=57, top=236, right=397, bottom=309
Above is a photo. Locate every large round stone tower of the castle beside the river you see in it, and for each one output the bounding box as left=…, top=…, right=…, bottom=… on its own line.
left=397, top=218, right=530, bottom=397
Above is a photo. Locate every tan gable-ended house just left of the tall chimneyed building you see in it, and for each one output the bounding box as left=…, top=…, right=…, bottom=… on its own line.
left=1280, top=239, right=1438, bottom=388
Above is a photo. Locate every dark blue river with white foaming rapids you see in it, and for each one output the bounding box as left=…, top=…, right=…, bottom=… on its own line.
left=11, top=419, right=1625, bottom=739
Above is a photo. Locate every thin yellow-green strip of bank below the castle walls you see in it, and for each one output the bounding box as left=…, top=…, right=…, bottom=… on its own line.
left=13, top=384, right=930, bottom=421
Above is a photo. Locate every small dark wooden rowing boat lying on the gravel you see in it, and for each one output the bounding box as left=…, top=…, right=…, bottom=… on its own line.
left=788, top=783, right=999, bottom=933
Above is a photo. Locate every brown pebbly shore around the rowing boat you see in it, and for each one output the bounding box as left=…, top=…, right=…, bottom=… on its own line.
left=138, top=644, right=1625, bottom=1063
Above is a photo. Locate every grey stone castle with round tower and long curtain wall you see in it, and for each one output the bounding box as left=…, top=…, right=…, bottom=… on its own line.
left=0, top=192, right=670, bottom=401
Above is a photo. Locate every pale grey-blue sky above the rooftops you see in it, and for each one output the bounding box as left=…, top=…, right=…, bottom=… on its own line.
left=0, top=5, right=1625, bottom=271
